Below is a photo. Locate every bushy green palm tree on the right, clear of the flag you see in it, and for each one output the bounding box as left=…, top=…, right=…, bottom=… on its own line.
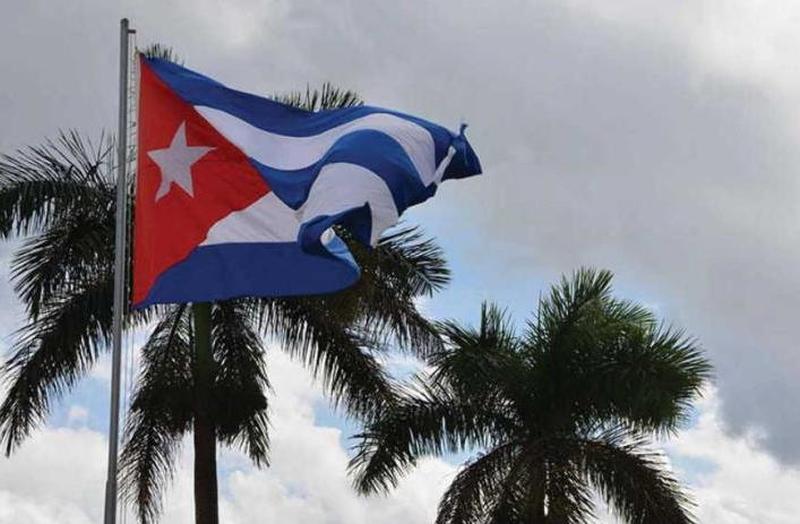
left=351, top=270, right=711, bottom=524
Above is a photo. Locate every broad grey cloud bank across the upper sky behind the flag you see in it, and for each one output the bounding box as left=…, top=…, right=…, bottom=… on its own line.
left=0, top=0, right=800, bottom=463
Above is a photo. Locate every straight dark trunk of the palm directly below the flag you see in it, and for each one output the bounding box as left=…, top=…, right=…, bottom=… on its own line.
left=192, top=303, right=219, bottom=524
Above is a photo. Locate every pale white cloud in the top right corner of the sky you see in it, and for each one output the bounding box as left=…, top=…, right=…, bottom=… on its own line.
left=567, top=0, right=800, bottom=113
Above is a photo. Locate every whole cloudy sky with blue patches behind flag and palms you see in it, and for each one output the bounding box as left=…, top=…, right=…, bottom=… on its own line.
left=0, top=0, right=800, bottom=524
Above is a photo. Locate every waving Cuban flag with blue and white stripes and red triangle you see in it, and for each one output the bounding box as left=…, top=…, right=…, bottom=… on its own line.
left=132, top=56, right=481, bottom=308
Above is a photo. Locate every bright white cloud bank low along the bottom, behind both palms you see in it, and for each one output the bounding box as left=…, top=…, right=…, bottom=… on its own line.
left=0, top=351, right=800, bottom=524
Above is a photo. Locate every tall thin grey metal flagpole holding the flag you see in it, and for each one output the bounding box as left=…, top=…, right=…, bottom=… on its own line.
left=103, top=18, right=132, bottom=524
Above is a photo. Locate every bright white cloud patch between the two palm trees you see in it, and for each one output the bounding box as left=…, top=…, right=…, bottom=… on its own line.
left=200, top=351, right=455, bottom=524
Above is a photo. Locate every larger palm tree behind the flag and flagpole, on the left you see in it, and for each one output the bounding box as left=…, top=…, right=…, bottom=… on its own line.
left=0, top=80, right=449, bottom=523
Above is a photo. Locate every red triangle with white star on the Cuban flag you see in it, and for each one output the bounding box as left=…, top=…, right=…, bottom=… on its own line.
left=132, top=55, right=270, bottom=304
